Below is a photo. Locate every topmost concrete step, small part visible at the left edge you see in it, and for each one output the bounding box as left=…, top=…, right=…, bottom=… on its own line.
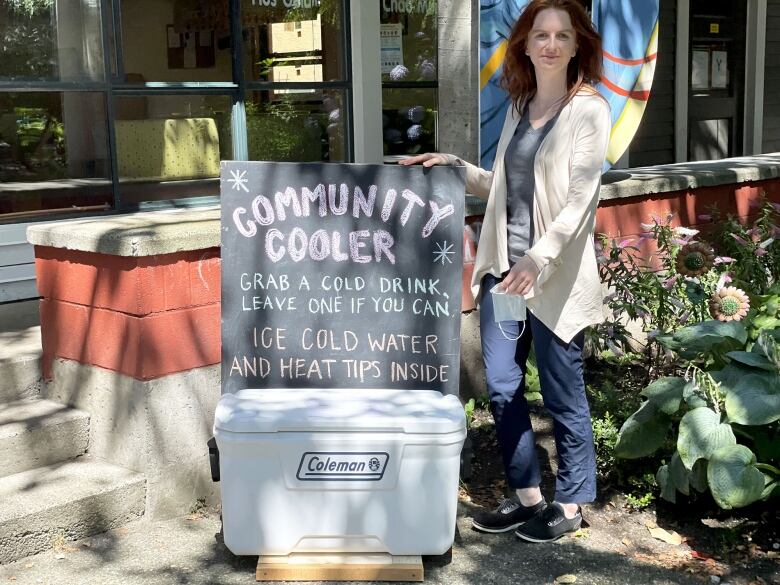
left=0, top=324, right=42, bottom=403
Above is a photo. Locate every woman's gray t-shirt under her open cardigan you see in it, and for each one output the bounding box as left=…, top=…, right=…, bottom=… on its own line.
left=504, top=108, right=558, bottom=263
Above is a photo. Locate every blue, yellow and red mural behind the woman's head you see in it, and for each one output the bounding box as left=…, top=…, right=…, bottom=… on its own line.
left=479, top=0, right=659, bottom=170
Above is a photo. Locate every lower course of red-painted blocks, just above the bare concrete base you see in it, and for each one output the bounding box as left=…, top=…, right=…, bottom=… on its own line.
left=41, top=299, right=221, bottom=380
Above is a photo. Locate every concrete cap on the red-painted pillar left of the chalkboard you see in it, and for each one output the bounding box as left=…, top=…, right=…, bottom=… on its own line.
left=27, top=207, right=220, bottom=256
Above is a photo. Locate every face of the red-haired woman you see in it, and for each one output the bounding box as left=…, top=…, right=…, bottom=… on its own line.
left=525, top=8, right=577, bottom=74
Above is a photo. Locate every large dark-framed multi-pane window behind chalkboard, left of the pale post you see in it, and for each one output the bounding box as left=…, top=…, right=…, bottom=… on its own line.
left=0, top=0, right=351, bottom=222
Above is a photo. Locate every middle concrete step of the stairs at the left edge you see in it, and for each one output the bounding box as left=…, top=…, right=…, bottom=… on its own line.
left=0, top=398, right=89, bottom=477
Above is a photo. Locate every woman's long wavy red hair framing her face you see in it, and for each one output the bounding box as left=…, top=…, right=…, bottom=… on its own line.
left=501, top=0, right=603, bottom=108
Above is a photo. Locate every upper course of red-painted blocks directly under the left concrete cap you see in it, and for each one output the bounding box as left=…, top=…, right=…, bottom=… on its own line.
left=35, top=246, right=220, bottom=315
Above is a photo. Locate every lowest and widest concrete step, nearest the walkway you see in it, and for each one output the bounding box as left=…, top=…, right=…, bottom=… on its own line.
left=0, top=456, right=146, bottom=564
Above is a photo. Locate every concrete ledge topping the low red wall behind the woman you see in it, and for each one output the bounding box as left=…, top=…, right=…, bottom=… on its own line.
left=466, top=153, right=780, bottom=216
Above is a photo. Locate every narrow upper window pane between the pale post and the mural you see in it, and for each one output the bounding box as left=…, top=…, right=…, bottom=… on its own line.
left=379, top=0, right=438, bottom=81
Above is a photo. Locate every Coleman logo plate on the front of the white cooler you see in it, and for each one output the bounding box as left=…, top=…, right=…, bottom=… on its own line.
left=296, top=451, right=389, bottom=481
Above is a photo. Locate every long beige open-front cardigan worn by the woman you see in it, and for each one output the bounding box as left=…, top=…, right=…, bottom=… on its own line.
left=448, top=92, right=611, bottom=343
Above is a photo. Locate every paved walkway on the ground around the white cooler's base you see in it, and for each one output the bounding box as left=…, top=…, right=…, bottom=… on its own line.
left=0, top=509, right=702, bottom=585
